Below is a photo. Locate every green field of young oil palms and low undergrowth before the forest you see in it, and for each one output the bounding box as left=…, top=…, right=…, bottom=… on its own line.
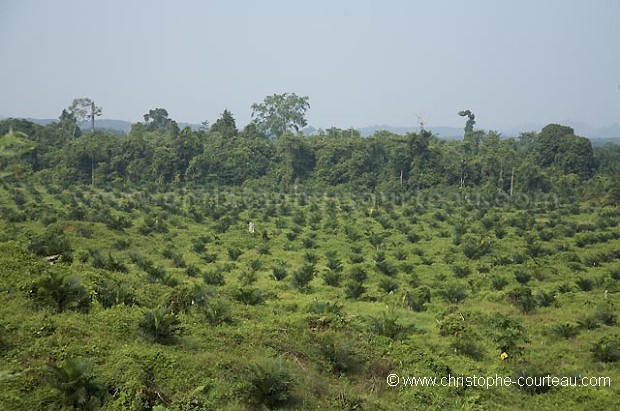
left=0, top=186, right=620, bottom=410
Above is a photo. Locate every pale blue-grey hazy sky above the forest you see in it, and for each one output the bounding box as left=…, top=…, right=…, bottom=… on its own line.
left=0, top=0, right=620, bottom=128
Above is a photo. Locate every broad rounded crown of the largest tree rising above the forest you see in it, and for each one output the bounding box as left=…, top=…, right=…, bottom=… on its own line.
left=252, top=93, right=310, bottom=138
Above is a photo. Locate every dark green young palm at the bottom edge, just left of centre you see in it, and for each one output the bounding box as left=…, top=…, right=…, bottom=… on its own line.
left=245, top=358, right=295, bottom=409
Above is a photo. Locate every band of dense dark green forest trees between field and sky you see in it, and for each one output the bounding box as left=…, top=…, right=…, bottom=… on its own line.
left=0, top=93, right=620, bottom=203
